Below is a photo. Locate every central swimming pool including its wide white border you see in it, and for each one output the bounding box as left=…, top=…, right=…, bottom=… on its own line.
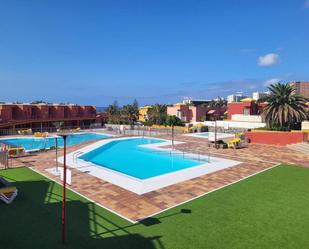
left=61, top=137, right=240, bottom=195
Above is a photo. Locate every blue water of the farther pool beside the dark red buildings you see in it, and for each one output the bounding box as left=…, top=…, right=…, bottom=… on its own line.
left=0, top=133, right=109, bottom=151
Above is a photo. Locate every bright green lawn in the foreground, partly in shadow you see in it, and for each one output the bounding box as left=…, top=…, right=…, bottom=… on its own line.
left=0, top=165, right=309, bottom=249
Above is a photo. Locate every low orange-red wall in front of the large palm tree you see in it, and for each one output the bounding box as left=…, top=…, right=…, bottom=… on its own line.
left=246, top=131, right=308, bottom=146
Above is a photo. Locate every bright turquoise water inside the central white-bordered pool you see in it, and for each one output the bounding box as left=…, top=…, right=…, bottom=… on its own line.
left=79, top=138, right=201, bottom=179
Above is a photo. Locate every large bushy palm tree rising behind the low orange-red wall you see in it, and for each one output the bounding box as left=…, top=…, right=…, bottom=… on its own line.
left=260, top=83, right=308, bottom=129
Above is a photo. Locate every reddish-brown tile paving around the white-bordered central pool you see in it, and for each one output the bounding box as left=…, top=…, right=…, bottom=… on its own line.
left=2, top=136, right=309, bottom=221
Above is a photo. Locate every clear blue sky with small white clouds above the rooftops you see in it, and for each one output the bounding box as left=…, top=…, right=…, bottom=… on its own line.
left=0, top=0, right=309, bottom=106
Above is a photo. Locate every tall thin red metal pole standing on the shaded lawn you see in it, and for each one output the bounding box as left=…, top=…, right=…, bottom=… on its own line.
left=61, top=135, right=67, bottom=244
